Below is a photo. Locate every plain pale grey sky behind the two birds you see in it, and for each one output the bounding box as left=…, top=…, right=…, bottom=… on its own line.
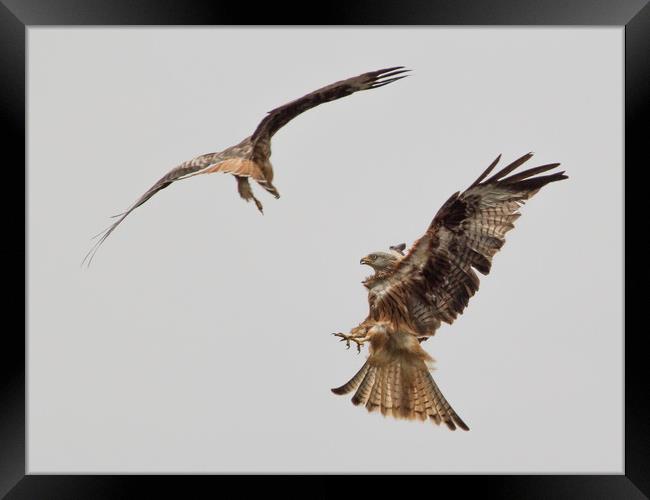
left=27, top=28, right=623, bottom=473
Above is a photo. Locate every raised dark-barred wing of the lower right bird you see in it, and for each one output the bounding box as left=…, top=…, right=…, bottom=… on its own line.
left=377, top=153, right=567, bottom=335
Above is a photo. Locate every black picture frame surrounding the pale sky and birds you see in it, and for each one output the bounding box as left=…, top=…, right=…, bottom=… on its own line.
left=0, top=0, right=650, bottom=499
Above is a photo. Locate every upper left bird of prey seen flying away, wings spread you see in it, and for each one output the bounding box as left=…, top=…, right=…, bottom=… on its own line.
left=82, top=66, right=410, bottom=264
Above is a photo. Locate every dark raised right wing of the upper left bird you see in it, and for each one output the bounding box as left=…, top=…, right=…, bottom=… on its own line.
left=252, top=66, right=409, bottom=144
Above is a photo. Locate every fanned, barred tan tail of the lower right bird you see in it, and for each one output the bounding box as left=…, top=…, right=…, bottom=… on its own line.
left=332, top=356, right=469, bottom=431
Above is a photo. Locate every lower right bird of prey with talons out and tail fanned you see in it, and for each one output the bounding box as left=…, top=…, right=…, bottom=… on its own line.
left=332, top=153, right=567, bottom=430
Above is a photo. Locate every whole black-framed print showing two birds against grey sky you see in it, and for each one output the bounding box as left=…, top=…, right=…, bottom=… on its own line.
left=0, top=0, right=650, bottom=498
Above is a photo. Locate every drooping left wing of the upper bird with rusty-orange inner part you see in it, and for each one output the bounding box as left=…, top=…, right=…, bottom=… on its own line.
left=81, top=150, right=254, bottom=266
